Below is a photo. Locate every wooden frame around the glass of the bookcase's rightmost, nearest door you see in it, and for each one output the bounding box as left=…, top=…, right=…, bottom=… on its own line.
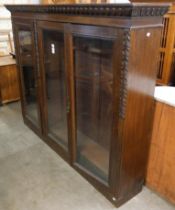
left=65, top=24, right=123, bottom=197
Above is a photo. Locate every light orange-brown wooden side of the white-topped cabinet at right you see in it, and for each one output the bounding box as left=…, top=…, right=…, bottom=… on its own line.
left=146, top=102, right=175, bottom=204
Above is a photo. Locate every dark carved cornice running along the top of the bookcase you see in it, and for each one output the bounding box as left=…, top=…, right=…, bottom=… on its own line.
left=6, top=4, right=169, bottom=17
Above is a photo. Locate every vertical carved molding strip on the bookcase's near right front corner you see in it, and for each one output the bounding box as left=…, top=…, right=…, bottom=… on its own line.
left=119, top=29, right=130, bottom=119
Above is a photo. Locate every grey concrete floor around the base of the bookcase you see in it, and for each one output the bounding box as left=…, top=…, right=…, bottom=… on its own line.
left=0, top=103, right=175, bottom=210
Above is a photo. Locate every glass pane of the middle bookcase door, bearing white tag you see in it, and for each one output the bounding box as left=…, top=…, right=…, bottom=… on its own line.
left=43, top=30, right=68, bottom=148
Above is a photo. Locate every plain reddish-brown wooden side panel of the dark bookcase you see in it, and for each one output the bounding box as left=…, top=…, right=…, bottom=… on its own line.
left=119, top=27, right=161, bottom=200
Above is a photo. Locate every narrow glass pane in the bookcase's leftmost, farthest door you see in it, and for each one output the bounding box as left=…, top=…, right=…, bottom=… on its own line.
left=18, top=29, right=39, bottom=127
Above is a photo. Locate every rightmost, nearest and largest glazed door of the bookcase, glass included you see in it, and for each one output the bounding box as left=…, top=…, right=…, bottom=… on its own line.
left=67, top=25, right=119, bottom=186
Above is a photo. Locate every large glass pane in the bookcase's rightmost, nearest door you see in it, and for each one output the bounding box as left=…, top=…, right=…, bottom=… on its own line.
left=74, top=37, right=113, bottom=181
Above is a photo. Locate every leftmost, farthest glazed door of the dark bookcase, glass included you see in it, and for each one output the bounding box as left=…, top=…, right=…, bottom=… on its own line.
left=14, top=21, right=41, bottom=133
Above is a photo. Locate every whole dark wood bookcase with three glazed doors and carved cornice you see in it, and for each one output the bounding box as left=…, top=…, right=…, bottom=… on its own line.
left=6, top=3, right=168, bottom=206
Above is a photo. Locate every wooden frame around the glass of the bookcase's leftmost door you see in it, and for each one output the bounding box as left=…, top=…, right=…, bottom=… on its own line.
left=12, top=18, right=43, bottom=137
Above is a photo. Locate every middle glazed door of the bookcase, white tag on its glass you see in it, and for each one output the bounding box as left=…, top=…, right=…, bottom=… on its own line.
left=38, top=21, right=69, bottom=153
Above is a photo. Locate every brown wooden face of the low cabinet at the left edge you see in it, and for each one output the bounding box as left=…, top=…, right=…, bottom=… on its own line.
left=0, top=65, right=20, bottom=103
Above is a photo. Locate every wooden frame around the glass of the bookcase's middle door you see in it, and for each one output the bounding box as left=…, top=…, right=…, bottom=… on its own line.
left=36, top=21, right=71, bottom=162
